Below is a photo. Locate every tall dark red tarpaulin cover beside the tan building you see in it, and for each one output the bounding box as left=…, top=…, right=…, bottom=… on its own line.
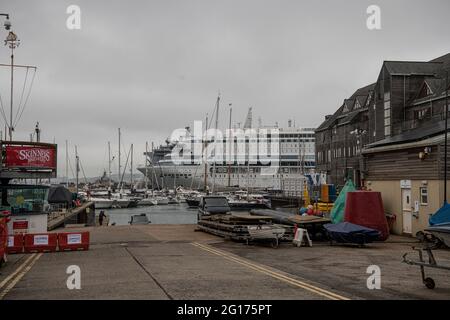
left=344, top=191, right=389, bottom=241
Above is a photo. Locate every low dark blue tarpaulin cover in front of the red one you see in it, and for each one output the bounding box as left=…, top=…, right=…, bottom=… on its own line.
left=323, top=222, right=380, bottom=244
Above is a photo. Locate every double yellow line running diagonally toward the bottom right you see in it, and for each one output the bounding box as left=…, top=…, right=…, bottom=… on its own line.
left=192, top=242, right=350, bottom=300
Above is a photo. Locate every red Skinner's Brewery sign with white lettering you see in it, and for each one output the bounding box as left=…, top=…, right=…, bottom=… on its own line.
left=5, top=146, right=56, bottom=169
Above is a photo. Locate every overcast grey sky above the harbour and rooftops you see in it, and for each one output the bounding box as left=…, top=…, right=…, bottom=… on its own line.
left=0, top=0, right=450, bottom=176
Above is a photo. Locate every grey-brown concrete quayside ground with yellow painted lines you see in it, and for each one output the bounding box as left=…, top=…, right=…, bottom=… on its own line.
left=0, top=225, right=450, bottom=299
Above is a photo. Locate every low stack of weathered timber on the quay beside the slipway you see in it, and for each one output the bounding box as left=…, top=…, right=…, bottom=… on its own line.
left=197, top=212, right=294, bottom=241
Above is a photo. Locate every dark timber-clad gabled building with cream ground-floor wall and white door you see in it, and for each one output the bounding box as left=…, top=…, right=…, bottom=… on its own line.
left=316, top=54, right=450, bottom=234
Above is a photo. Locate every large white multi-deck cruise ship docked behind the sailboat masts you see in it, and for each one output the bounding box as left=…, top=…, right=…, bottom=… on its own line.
left=138, top=110, right=324, bottom=196
